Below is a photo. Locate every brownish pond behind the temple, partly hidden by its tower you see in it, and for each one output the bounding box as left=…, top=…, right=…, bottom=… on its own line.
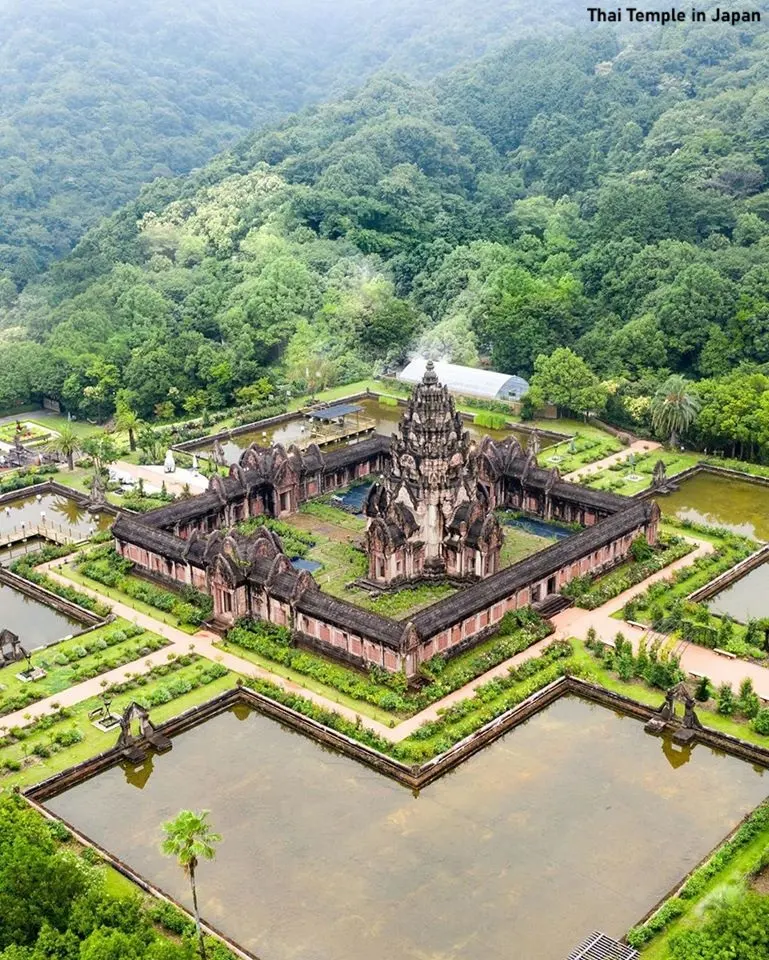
left=188, top=399, right=554, bottom=464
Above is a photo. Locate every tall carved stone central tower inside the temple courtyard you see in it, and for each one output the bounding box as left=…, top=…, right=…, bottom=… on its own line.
left=365, top=361, right=502, bottom=584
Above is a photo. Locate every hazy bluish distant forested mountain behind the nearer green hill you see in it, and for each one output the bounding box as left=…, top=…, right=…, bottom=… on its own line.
left=0, top=0, right=573, bottom=284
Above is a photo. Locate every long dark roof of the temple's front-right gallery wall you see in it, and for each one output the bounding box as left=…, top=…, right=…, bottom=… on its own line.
left=412, top=501, right=651, bottom=637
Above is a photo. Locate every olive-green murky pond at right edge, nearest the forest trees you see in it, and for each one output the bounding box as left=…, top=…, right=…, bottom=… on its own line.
left=656, top=472, right=769, bottom=540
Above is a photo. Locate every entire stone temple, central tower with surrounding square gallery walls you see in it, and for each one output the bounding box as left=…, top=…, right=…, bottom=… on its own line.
left=112, top=369, right=660, bottom=678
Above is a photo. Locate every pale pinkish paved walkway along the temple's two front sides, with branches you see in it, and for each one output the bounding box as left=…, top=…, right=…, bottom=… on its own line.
left=9, top=537, right=769, bottom=743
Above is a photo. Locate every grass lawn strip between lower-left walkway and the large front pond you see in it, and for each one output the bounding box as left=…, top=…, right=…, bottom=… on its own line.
left=0, top=653, right=238, bottom=790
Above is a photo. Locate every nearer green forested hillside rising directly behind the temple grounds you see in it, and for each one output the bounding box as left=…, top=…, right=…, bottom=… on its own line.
left=0, top=6, right=769, bottom=454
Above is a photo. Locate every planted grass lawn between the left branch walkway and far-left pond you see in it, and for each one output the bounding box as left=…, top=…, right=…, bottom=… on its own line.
left=0, top=619, right=168, bottom=723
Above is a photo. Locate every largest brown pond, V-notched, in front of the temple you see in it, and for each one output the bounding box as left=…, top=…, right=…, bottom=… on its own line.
left=46, top=697, right=769, bottom=960
